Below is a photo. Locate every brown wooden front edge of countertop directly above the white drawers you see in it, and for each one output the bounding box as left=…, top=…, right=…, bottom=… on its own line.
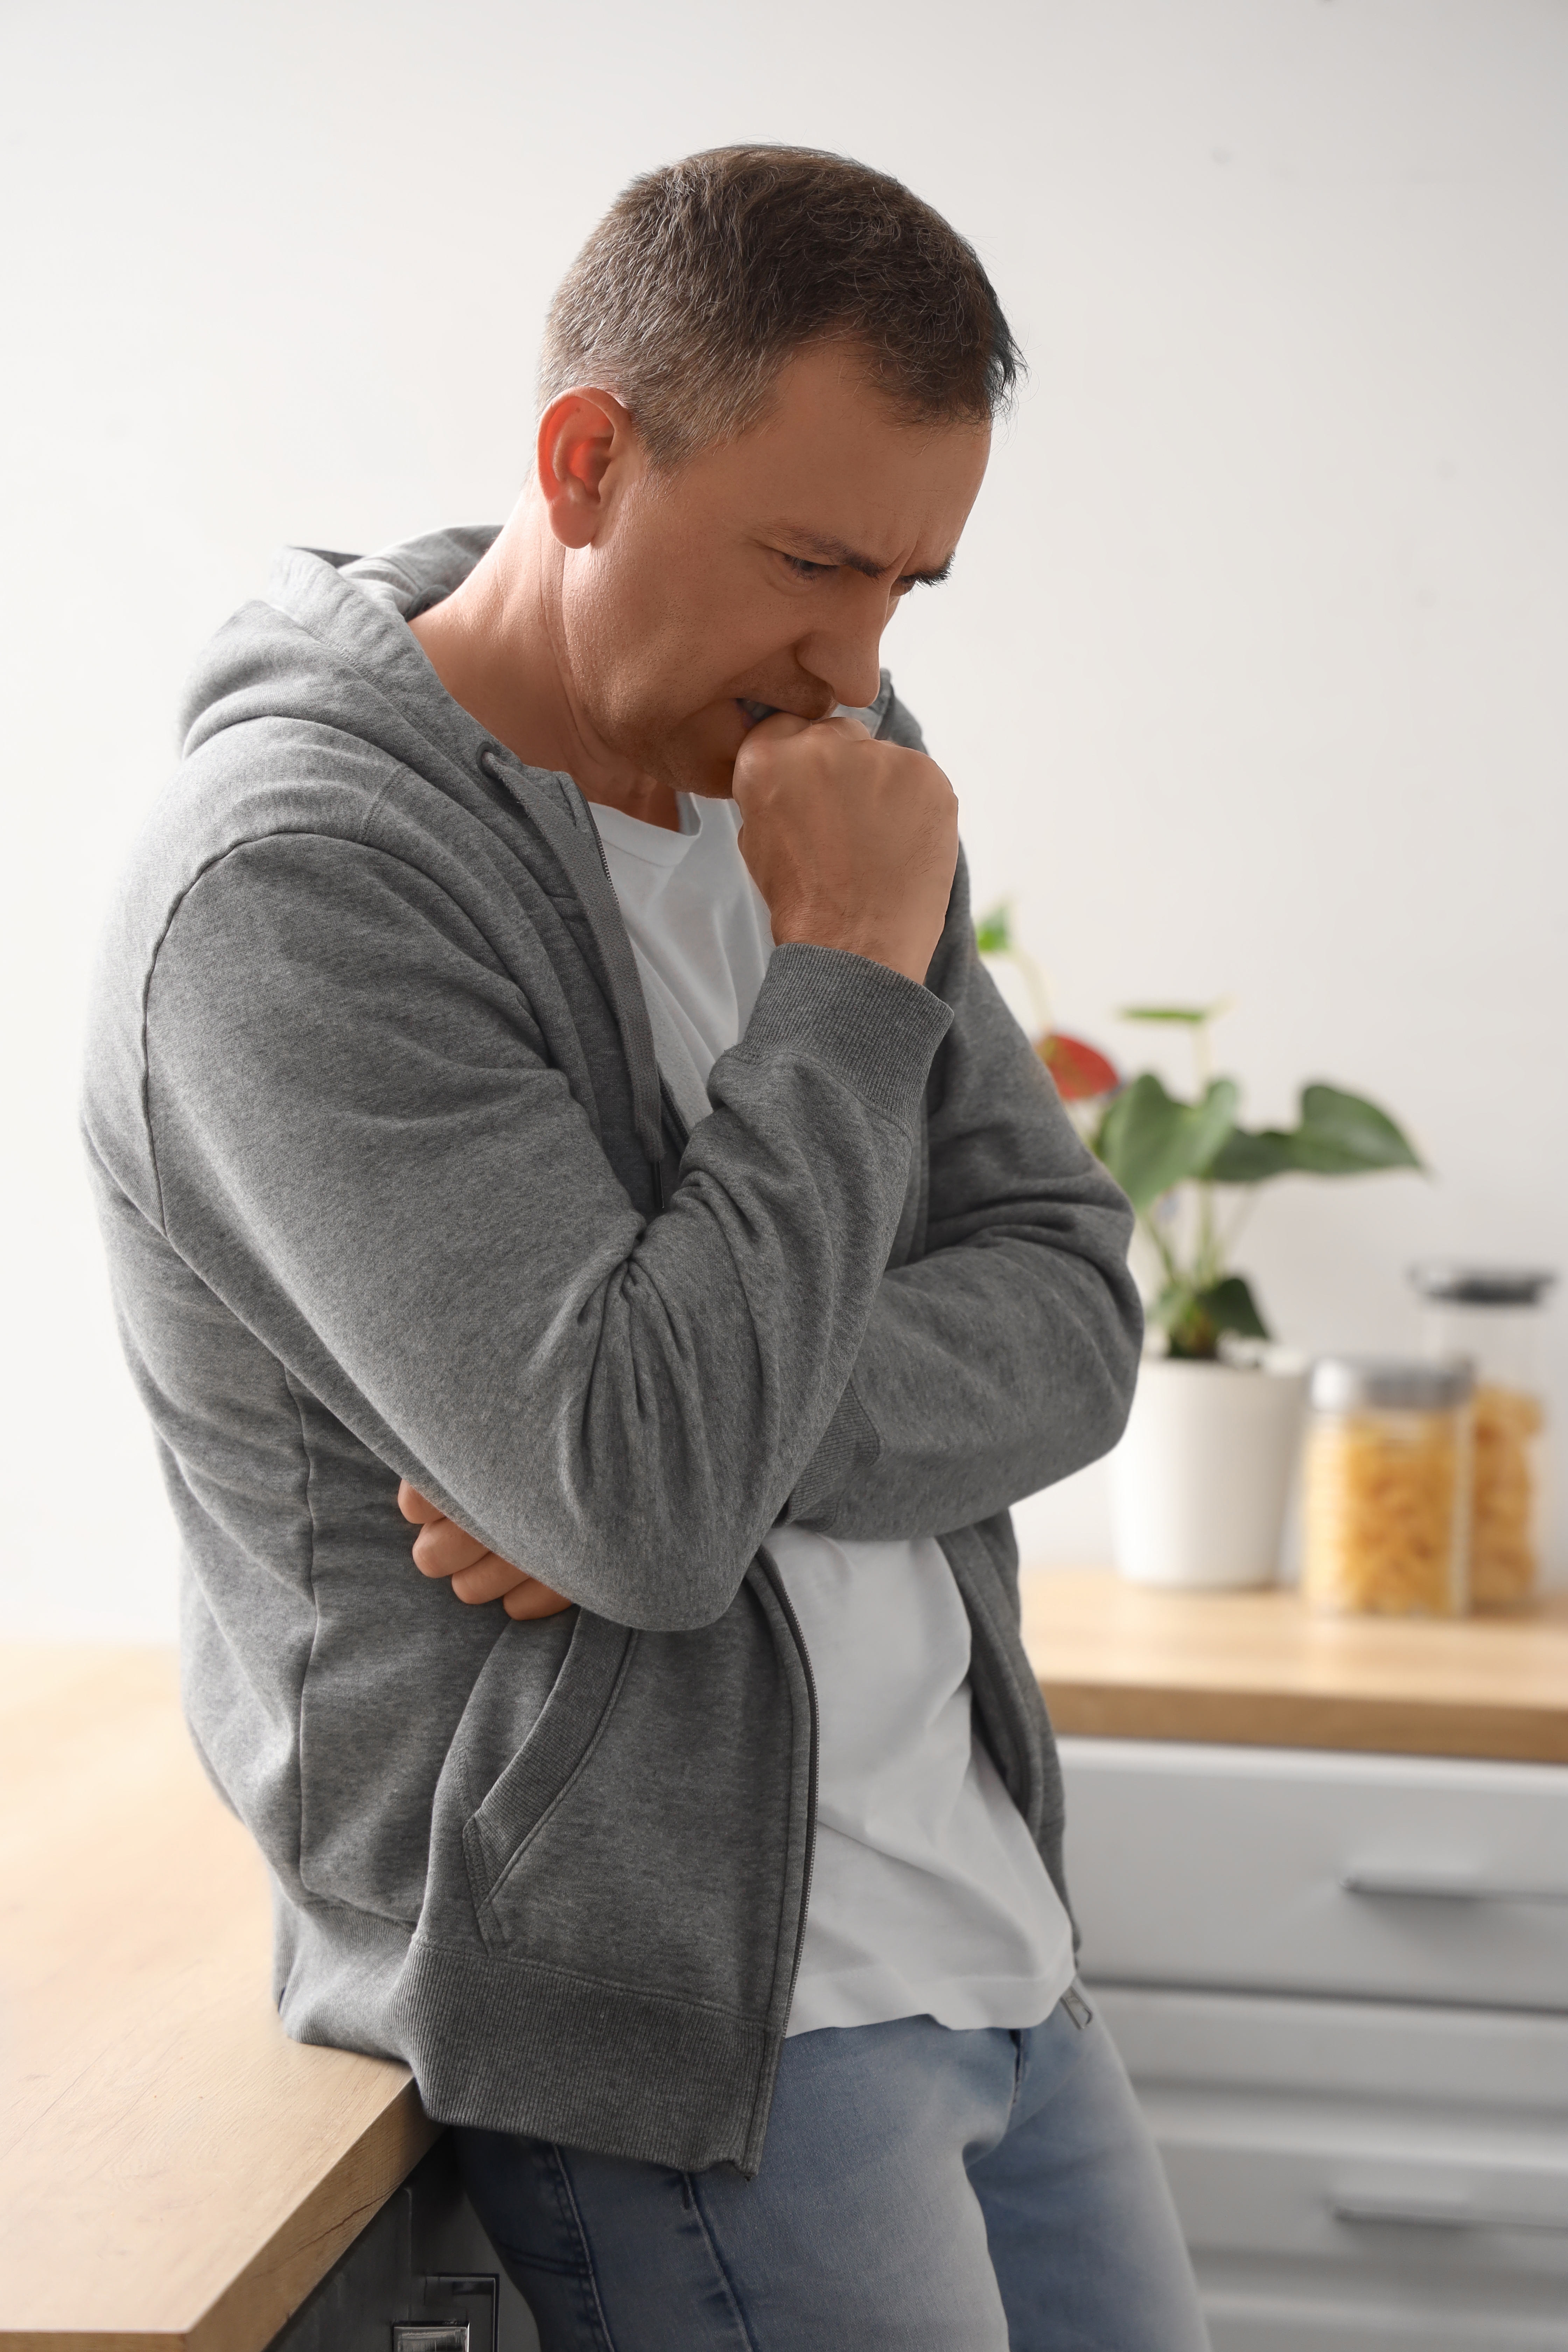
left=1039, top=1675, right=1568, bottom=1764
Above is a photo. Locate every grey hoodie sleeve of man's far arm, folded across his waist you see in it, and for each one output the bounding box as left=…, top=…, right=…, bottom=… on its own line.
left=788, top=847, right=1142, bottom=1541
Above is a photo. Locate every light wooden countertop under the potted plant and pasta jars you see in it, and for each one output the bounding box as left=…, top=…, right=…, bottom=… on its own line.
left=1023, top=1569, right=1568, bottom=1764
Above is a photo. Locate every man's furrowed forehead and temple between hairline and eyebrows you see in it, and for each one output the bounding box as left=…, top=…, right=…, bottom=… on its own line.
left=682, top=343, right=990, bottom=565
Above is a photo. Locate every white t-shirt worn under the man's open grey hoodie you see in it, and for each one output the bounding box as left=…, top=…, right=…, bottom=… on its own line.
left=593, top=795, right=1072, bottom=2035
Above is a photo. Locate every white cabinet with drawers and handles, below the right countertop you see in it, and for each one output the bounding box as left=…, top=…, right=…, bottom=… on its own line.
left=1063, top=1741, right=1568, bottom=2352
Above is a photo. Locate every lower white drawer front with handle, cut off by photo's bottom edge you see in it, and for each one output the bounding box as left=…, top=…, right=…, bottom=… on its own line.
left=1091, top=1980, right=1568, bottom=2352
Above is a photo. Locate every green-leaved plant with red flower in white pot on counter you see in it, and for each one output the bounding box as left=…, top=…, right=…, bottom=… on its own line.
left=975, top=908, right=1422, bottom=1585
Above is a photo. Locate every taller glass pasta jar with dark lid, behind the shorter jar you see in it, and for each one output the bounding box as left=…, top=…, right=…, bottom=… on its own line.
left=1410, top=1265, right=1556, bottom=1609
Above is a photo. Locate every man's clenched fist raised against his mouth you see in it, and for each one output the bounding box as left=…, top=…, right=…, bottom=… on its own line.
left=736, top=710, right=959, bottom=983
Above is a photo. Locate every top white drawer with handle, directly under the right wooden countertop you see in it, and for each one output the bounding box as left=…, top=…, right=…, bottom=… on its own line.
left=1063, top=1741, right=1568, bottom=2011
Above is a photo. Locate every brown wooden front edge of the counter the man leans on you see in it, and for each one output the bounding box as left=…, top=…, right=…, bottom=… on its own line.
left=0, top=2081, right=444, bottom=2352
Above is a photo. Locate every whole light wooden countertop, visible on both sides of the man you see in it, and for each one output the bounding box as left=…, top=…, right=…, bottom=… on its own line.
left=0, top=1571, right=1568, bottom=2352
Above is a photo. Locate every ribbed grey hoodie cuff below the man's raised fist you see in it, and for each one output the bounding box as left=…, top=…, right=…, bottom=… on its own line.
left=736, top=943, right=952, bottom=1131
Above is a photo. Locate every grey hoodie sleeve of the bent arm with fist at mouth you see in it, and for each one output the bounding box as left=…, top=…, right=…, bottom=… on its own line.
left=146, top=833, right=952, bottom=1630
